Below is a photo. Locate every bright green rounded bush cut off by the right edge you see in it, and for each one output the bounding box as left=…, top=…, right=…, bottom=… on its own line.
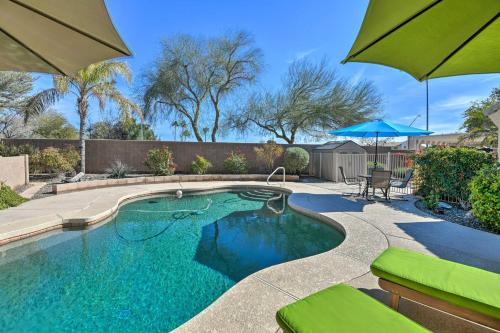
left=469, top=163, right=500, bottom=232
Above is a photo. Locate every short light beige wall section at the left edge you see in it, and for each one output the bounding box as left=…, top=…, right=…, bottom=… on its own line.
left=0, top=155, right=29, bottom=189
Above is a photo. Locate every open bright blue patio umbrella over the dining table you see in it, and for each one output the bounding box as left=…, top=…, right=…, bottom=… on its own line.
left=329, top=119, right=432, bottom=167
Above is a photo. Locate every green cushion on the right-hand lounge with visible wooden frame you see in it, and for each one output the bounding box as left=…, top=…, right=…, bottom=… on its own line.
left=371, top=247, right=500, bottom=319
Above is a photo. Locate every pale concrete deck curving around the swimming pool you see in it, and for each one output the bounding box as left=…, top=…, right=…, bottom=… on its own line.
left=0, top=181, right=500, bottom=332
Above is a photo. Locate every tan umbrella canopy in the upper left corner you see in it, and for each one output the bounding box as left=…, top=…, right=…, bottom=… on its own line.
left=0, top=0, right=131, bottom=75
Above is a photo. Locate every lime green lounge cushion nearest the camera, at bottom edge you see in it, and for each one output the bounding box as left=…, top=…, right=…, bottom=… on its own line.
left=276, top=284, right=429, bottom=333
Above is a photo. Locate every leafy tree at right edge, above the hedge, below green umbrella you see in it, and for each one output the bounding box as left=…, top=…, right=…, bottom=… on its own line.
left=462, top=87, right=500, bottom=147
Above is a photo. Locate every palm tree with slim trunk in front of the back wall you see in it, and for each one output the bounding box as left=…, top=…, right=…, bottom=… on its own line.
left=53, top=61, right=143, bottom=172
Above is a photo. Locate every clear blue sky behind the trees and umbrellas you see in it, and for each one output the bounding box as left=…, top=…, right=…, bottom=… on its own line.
left=36, top=0, right=500, bottom=142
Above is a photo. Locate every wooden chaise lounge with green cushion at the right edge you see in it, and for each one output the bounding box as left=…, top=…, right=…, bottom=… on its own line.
left=370, top=247, right=500, bottom=330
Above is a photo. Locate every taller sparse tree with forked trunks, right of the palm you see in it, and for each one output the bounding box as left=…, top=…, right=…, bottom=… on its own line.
left=142, top=32, right=260, bottom=142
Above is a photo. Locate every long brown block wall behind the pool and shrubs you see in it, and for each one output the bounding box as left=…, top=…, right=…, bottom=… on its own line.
left=4, top=139, right=318, bottom=173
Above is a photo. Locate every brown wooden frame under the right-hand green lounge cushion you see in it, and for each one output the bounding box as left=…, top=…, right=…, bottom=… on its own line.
left=378, top=278, right=500, bottom=330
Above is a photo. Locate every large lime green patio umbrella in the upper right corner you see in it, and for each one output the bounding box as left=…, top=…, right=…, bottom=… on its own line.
left=342, top=0, right=500, bottom=129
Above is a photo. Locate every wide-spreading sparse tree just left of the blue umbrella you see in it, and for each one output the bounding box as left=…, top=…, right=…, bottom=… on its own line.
left=226, top=59, right=380, bottom=143
